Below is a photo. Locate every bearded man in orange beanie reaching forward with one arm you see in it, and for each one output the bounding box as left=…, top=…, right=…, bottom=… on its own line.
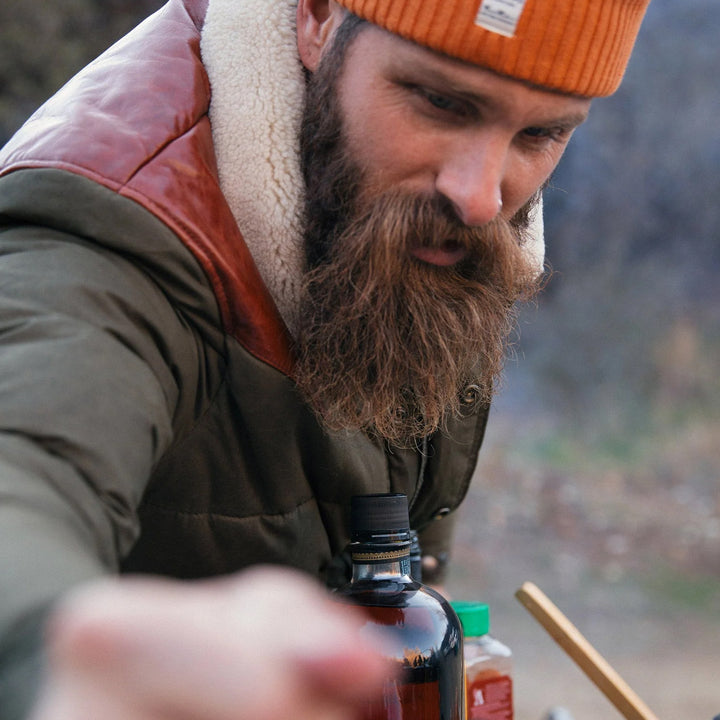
left=0, top=0, right=647, bottom=720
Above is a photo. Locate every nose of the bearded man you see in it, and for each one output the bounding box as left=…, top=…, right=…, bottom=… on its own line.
left=435, top=138, right=508, bottom=227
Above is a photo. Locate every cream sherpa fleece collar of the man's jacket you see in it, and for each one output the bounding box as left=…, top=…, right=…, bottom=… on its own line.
left=201, top=0, right=544, bottom=332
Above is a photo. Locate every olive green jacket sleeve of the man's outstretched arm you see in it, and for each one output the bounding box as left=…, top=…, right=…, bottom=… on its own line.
left=0, top=167, right=222, bottom=720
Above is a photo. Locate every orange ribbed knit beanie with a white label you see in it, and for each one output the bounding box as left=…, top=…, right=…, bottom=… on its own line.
left=337, top=0, right=650, bottom=97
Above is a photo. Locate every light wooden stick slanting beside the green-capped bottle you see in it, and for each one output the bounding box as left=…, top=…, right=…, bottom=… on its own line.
left=515, top=582, right=658, bottom=720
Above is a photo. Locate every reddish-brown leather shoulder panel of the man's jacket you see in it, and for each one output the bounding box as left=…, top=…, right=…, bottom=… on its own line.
left=0, top=0, right=292, bottom=374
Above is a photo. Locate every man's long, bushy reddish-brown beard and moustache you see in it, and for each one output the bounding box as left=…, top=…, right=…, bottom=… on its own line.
left=295, top=19, right=538, bottom=446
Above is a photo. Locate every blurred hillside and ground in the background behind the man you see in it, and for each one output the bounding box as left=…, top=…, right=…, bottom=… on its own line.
left=0, top=0, right=720, bottom=720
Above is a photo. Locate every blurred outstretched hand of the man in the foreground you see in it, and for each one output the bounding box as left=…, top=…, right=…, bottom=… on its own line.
left=31, top=568, right=389, bottom=720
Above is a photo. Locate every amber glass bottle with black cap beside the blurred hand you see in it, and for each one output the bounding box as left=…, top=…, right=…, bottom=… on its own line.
left=337, top=494, right=464, bottom=720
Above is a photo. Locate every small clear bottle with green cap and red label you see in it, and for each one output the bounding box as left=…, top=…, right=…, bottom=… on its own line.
left=450, top=601, right=513, bottom=720
